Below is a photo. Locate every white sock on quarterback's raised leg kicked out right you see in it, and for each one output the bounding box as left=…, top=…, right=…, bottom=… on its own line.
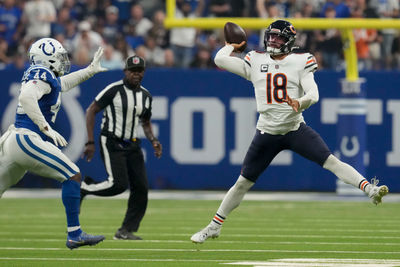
left=322, top=155, right=371, bottom=194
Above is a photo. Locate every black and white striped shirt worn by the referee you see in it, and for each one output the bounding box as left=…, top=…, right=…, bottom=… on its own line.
left=95, top=80, right=152, bottom=140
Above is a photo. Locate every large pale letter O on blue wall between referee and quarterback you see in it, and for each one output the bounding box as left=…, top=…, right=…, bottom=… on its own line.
left=171, top=97, right=225, bottom=164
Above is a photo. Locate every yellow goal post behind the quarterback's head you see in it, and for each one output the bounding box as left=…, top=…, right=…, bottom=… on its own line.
left=164, top=0, right=400, bottom=81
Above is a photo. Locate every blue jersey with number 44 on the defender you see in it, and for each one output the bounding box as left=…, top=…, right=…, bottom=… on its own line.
left=15, top=65, right=61, bottom=140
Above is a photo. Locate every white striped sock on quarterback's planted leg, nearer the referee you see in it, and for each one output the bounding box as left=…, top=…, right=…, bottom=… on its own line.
left=210, top=175, right=254, bottom=227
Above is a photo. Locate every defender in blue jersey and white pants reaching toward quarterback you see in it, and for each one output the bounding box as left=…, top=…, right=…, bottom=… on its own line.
left=0, top=38, right=107, bottom=249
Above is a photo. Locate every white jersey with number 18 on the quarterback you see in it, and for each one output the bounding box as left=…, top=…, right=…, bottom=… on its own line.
left=244, top=51, right=317, bottom=134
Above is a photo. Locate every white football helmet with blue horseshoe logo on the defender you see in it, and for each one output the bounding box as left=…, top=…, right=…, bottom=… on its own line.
left=28, top=38, right=71, bottom=76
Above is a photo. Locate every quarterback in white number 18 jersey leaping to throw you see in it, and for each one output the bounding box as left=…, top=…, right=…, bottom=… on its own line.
left=191, top=20, right=388, bottom=243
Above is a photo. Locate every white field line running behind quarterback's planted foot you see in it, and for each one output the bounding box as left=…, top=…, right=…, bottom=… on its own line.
left=0, top=238, right=400, bottom=248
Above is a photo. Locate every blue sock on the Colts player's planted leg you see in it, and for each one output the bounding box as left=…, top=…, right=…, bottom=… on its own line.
left=61, top=180, right=82, bottom=237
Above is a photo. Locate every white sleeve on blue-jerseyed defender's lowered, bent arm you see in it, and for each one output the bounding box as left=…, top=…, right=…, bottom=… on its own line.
left=18, top=80, right=51, bottom=130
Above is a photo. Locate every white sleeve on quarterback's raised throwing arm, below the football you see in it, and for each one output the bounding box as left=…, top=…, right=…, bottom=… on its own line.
left=214, top=45, right=250, bottom=80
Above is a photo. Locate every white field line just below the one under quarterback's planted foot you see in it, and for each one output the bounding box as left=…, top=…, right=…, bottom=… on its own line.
left=0, top=247, right=400, bottom=255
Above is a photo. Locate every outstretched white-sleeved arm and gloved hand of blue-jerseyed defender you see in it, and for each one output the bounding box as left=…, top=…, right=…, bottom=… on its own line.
left=60, top=47, right=107, bottom=92
